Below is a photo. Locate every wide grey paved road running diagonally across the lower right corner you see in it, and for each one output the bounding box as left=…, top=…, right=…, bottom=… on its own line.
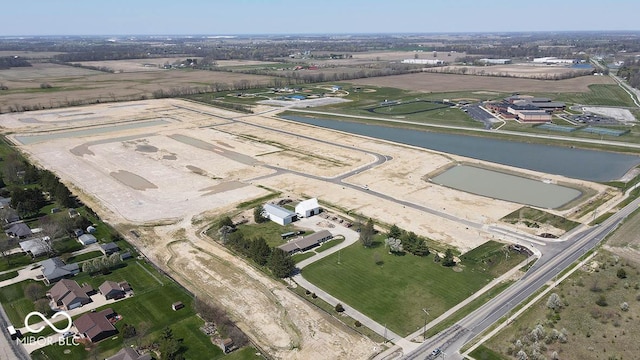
left=403, top=198, right=640, bottom=359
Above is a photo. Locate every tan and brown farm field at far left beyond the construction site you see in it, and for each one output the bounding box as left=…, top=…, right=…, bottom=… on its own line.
left=0, top=63, right=271, bottom=113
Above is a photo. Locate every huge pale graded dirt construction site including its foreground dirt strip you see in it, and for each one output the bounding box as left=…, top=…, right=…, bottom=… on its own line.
left=0, top=99, right=617, bottom=359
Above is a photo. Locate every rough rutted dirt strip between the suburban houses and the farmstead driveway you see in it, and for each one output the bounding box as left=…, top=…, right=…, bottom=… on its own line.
left=126, top=215, right=376, bottom=359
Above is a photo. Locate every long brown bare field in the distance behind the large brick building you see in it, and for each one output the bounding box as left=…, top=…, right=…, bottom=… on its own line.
left=351, top=73, right=614, bottom=92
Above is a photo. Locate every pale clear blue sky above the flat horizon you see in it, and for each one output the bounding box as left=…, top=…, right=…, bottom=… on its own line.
left=0, top=0, right=640, bottom=36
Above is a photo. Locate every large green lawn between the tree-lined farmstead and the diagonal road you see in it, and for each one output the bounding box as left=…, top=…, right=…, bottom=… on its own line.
left=302, top=242, right=524, bottom=335
